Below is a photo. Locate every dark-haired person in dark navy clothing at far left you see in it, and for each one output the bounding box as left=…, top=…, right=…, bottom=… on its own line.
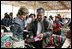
left=1, top=13, right=12, bottom=27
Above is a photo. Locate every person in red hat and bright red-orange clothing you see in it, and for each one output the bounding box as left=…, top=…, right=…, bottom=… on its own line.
left=53, top=16, right=61, bottom=35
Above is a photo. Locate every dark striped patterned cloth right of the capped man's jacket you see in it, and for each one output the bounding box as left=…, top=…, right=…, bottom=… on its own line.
left=52, top=35, right=66, bottom=47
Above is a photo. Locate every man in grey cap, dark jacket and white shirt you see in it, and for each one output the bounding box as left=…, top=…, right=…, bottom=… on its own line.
left=29, top=8, right=53, bottom=48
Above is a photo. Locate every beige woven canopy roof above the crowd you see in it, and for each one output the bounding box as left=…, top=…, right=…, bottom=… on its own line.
left=1, top=1, right=71, bottom=10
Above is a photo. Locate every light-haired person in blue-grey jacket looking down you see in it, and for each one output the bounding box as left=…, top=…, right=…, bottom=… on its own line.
left=11, top=7, right=28, bottom=40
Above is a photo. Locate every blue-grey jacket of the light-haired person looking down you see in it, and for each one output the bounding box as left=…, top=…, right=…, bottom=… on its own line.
left=11, top=17, right=24, bottom=40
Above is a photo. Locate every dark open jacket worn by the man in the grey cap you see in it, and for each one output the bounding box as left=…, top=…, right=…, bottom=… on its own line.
left=29, top=19, right=53, bottom=47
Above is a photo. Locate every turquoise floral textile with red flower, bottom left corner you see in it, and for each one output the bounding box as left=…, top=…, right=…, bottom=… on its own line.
left=1, top=36, right=13, bottom=48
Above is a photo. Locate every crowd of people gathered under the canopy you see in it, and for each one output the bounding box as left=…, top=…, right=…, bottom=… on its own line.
left=1, top=7, right=71, bottom=48
